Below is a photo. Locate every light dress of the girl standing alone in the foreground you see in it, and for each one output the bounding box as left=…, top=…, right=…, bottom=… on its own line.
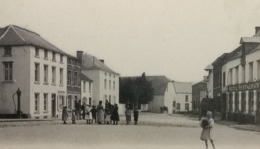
left=200, top=118, right=214, bottom=141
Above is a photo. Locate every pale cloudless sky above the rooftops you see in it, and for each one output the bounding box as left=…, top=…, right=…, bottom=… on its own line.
left=0, top=0, right=260, bottom=82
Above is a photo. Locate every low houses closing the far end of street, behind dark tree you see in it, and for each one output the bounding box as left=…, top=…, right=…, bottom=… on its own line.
left=121, top=76, right=192, bottom=114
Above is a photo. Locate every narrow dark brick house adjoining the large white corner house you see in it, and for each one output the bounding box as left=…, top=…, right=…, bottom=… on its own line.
left=66, top=56, right=81, bottom=111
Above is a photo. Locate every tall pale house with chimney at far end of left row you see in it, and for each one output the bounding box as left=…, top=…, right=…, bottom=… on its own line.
left=77, top=51, right=119, bottom=105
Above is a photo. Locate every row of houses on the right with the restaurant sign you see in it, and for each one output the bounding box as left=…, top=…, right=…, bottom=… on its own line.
left=193, top=27, right=260, bottom=123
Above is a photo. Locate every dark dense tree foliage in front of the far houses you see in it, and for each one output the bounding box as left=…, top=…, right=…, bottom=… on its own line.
left=119, top=73, right=154, bottom=107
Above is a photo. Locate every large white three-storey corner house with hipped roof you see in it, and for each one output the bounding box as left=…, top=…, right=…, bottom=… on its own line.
left=0, top=25, right=67, bottom=118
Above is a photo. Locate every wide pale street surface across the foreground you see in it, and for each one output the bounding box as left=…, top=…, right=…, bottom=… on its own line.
left=0, top=113, right=260, bottom=149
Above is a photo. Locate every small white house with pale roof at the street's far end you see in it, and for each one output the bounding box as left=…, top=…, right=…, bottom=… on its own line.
left=173, top=82, right=192, bottom=113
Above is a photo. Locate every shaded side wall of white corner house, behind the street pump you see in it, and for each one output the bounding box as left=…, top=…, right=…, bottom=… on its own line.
left=0, top=46, right=31, bottom=114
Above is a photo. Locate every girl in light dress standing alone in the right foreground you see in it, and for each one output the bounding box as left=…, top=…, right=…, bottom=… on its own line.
left=200, top=111, right=216, bottom=149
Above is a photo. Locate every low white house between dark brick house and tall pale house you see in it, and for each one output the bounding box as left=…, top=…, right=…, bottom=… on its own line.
left=80, top=74, right=93, bottom=105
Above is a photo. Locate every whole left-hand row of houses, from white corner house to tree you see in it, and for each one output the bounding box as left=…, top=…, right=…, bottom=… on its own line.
left=0, top=25, right=119, bottom=118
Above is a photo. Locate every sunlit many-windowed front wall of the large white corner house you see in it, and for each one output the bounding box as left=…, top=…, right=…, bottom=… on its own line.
left=29, top=47, right=67, bottom=118
